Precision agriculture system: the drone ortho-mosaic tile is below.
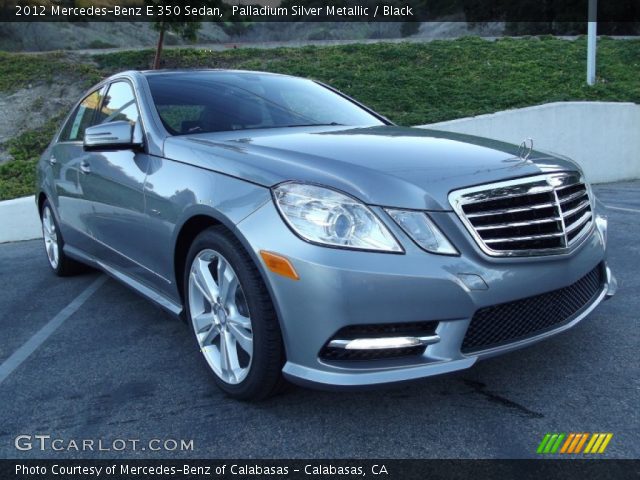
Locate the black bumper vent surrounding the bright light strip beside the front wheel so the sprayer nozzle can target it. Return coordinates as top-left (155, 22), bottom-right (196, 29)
top-left (320, 321), bottom-right (438, 360)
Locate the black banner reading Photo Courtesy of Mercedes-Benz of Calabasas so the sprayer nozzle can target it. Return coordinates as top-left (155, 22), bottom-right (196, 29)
top-left (0, 459), bottom-right (640, 480)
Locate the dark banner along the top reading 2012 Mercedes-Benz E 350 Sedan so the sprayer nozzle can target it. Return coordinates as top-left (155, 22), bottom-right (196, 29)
top-left (0, 0), bottom-right (640, 23)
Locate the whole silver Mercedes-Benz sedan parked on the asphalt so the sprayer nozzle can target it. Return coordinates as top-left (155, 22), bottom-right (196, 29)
top-left (36, 70), bottom-right (615, 399)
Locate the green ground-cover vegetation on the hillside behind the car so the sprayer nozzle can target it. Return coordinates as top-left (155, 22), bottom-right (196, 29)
top-left (0, 37), bottom-right (640, 199)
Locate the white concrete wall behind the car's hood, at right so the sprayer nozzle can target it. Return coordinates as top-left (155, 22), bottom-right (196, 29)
top-left (421, 102), bottom-right (640, 183)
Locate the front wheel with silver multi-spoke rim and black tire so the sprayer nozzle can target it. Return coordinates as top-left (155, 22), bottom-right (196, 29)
top-left (183, 227), bottom-right (285, 401)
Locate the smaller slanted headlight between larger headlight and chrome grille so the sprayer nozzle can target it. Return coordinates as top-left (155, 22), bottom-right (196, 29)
top-left (387, 209), bottom-right (458, 255)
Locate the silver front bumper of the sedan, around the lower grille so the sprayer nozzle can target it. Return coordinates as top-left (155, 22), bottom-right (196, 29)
top-left (237, 202), bottom-right (615, 387)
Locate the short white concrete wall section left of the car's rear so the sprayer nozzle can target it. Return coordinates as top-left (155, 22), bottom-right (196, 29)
top-left (0, 195), bottom-right (42, 243)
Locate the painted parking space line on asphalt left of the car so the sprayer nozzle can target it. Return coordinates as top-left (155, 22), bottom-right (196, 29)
top-left (0, 275), bottom-right (108, 384)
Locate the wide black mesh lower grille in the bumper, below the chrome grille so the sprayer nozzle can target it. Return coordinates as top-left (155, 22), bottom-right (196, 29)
top-left (462, 265), bottom-right (604, 353)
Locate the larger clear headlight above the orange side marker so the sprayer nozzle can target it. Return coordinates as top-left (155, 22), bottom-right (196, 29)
top-left (273, 183), bottom-right (403, 253)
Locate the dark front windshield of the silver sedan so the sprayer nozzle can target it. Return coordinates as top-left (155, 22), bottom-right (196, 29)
top-left (147, 72), bottom-right (383, 135)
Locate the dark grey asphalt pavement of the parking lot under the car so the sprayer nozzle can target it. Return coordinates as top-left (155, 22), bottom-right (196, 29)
top-left (0, 182), bottom-right (640, 459)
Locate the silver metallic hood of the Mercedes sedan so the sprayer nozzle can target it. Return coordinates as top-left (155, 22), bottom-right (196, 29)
top-left (164, 125), bottom-right (578, 210)
